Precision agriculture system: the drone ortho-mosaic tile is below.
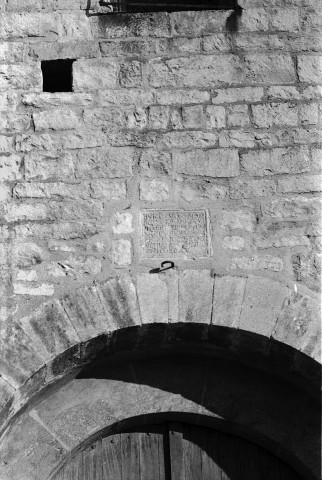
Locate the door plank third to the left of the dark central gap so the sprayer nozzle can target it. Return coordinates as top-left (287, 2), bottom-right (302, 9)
top-left (102, 434), bottom-right (122, 480)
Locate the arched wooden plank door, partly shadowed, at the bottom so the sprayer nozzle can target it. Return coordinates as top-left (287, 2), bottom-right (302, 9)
top-left (54, 423), bottom-right (300, 480)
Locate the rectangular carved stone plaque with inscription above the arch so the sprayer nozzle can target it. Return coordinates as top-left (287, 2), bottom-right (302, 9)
top-left (141, 210), bottom-right (209, 259)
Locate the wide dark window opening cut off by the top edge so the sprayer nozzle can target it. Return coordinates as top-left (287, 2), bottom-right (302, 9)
top-left (100, 0), bottom-right (238, 13)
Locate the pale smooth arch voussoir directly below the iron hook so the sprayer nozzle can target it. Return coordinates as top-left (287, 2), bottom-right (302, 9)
top-left (136, 273), bottom-right (170, 324)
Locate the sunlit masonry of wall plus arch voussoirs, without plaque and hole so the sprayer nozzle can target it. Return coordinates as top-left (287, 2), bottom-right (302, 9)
top-left (0, 0), bottom-right (322, 480)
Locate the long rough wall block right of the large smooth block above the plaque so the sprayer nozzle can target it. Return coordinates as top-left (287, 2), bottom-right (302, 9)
top-left (241, 146), bottom-right (312, 177)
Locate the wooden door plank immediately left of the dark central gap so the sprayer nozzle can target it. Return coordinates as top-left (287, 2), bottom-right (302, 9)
top-left (140, 427), bottom-right (165, 480)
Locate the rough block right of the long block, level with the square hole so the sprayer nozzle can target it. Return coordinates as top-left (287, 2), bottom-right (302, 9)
top-left (244, 54), bottom-right (296, 84)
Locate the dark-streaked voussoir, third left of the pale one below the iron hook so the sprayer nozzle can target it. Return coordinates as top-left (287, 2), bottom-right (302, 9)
top-left (20, 300), bottom-right (79, 360)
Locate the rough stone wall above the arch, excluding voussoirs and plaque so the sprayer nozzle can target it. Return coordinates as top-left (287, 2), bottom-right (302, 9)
top-left (0, 0), bottom-right (322, 317)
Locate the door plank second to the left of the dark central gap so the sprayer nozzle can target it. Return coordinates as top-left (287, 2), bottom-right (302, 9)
top-left (120, 432), bottom-right (140, 480)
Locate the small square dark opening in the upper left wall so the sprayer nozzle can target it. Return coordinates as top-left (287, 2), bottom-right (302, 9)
top-left (41, 59), bottom-right (75, 93)
